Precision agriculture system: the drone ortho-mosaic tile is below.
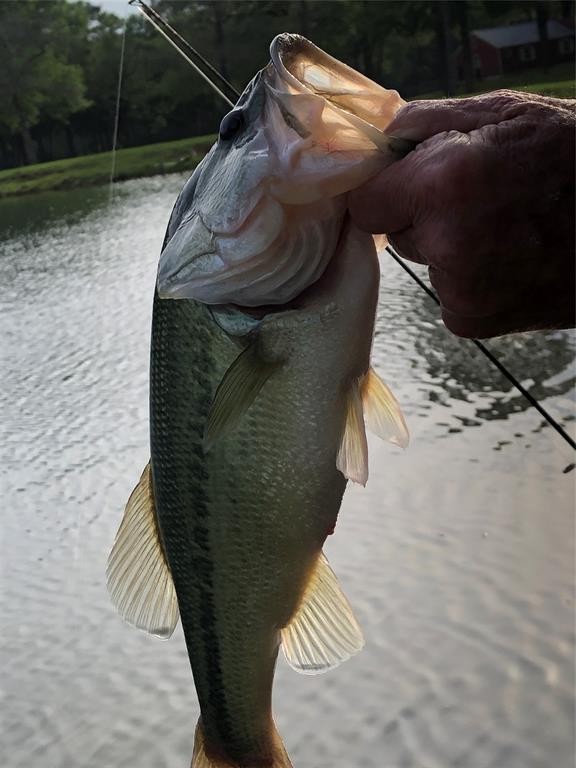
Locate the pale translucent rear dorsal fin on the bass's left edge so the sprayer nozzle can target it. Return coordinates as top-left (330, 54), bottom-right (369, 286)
top-left (106, 462), bottom-right (179, 639)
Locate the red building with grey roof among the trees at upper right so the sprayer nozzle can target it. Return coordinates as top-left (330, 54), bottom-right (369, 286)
top-left (466, 21), bottom-right (574, 78)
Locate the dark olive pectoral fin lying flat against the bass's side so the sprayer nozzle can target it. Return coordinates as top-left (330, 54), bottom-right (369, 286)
top-left (204, 344), bottom-right (280, 451)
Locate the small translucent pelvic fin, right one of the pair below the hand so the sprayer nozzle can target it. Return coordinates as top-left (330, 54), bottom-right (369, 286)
top-left (360, 368), bottom-right (409, 448)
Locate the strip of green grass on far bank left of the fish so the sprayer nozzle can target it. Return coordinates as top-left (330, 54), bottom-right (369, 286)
top-left (0, 136), bottom-right (216, 197)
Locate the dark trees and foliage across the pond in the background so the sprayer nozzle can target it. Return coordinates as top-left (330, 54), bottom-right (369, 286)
top-left (0, 0), bottom-right (574, 167)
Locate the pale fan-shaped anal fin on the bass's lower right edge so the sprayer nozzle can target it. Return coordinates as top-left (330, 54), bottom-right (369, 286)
top-left (281, 553), bottom-right (364, 675)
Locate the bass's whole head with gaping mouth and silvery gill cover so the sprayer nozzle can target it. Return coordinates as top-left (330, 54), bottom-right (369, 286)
top-left (158, 34), bottom-right (404, 307)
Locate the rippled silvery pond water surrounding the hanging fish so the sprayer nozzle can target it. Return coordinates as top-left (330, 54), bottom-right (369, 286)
top-left (0, 176), bottom-right (575, 768)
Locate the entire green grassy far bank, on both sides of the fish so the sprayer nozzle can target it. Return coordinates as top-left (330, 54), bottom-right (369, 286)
top-left (0, 64), bottom-right (576, 198)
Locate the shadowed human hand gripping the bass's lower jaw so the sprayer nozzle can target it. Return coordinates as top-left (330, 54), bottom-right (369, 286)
top-left (349, 91), bottom-right (576, 338)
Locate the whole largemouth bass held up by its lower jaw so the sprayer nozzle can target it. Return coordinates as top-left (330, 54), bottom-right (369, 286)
top-left (108, 35), bottom-right (407, 768)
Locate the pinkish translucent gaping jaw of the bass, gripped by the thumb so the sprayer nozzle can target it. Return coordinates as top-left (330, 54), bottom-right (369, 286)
top-left (264, 33), bottom-right (406, 202)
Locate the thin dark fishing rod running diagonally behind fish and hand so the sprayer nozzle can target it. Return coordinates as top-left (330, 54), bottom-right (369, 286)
top-left (129, 0), bottom-right (576, 456)
